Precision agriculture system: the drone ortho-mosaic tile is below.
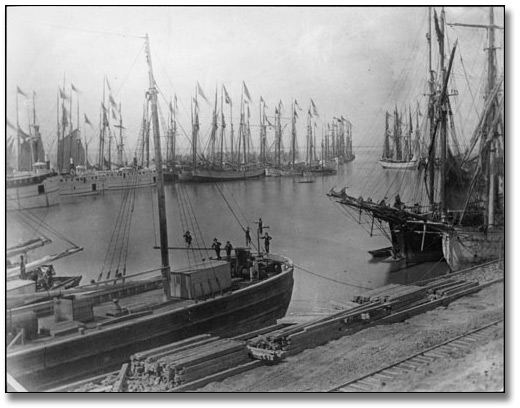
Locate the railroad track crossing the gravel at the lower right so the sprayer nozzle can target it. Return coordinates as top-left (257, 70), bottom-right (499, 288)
top-left (327, 319), bottom-right (504, 392)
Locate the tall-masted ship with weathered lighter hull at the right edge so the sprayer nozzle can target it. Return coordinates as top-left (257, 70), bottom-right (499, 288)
top-left (436, 7), bottom-right (505, 270)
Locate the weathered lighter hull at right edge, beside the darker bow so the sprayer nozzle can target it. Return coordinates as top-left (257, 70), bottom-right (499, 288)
top-left (442, 228), bottom-right (505, 271)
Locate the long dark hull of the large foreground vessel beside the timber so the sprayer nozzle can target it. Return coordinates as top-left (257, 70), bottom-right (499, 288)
top-left (7, 266), bottom-right (294, 390)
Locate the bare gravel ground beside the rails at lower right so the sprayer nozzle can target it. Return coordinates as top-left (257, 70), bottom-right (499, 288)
top-left (198, 266), bottom-right (505, 392)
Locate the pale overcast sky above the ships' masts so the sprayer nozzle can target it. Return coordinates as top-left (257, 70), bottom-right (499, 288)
top-left (6, 7), bottom-right (503, 163)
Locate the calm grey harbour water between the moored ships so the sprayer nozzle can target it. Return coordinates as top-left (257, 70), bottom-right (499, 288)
top-left (7, 148), bottom-right (447, 314)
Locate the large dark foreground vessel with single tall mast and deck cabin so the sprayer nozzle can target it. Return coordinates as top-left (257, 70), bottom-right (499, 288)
top-left (7, 36), bottom-right (294, 390)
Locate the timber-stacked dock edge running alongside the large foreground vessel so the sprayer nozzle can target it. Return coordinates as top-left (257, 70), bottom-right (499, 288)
top-left (45, 277), bottom-right (503, 392)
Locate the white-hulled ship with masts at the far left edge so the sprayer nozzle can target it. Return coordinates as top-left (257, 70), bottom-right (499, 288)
top-left (5, 88), bottom-right (59, 211)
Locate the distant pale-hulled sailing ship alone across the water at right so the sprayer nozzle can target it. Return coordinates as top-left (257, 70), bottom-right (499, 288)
top-left (379, 107), bottom-right (420, 170)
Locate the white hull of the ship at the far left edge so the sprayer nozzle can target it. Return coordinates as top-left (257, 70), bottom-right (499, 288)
top-left (6, 175), bottom-right (60, 211)
